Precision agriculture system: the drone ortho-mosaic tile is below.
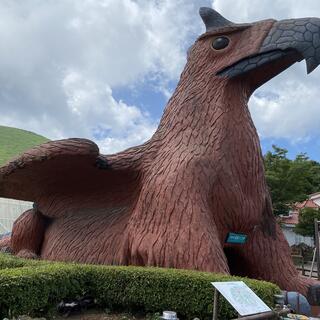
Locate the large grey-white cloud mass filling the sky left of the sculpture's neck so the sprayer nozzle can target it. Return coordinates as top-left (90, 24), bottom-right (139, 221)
top-left (0, 0), bottom-right (205, 152)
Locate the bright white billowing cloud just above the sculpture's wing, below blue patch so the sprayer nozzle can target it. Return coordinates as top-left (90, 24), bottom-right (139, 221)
top-left (62, 71), bottom-right (156, 148)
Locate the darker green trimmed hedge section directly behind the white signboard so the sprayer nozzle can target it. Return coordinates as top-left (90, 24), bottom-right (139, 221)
top-left (93, 267), bottom-right (280, 319)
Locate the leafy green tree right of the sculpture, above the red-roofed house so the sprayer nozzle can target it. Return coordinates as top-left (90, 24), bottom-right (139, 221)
top-left (264, 145), bottom-right (320, 215)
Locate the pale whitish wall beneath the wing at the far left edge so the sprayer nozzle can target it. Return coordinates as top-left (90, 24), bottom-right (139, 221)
top-left (0, 198), bottom-right (33, 234)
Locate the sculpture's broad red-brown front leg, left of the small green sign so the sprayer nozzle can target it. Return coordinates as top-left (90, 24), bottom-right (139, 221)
top-left (127, 173), bottom-right (229, 273)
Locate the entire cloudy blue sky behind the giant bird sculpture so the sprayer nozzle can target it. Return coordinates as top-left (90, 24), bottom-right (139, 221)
top-left (0, 0), bottom-right (320, 161)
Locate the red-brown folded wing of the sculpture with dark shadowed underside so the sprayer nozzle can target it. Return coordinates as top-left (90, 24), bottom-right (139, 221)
top-left (0, 139), bottom-right (134, 201)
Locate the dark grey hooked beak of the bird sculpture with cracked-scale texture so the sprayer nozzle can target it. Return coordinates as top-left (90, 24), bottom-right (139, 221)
top-left (217, 18), bottom-right (320, 78)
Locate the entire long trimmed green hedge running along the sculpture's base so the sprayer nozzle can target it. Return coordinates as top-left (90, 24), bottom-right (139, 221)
top-left (0, 255), bottom-right (279, 319)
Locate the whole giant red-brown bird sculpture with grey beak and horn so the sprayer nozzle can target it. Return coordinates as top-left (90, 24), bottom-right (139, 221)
top-left (0, 8), bottom-right (320, 300)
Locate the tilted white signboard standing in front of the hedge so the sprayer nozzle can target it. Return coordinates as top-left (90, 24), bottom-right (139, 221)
top-left (211, 281), bottom-right (271, 316)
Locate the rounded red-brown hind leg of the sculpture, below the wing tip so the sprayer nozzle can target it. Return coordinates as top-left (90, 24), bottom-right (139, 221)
top-left (11, 209), bottom-right (46, 258)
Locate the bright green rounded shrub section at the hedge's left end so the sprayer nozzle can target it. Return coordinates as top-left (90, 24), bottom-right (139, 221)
top-left (0, 263), bottom-right (92, 317)
